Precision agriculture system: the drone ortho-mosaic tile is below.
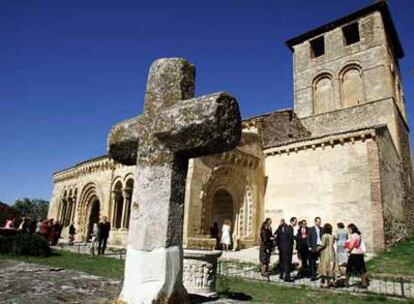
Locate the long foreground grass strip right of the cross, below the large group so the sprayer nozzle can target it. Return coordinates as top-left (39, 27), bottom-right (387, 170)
top-left (217, 277), bottom-right (414, 304)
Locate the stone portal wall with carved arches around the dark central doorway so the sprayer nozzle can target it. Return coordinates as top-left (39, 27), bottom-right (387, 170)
top-left (184, 132), bottom-right (264, 248)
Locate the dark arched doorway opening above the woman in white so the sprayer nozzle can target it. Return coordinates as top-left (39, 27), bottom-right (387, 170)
top-left (210, 189), bottom-right (235, 239)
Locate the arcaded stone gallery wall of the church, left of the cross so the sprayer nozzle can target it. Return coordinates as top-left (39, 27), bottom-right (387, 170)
top-left (48, 156), bottom-right (134, 245)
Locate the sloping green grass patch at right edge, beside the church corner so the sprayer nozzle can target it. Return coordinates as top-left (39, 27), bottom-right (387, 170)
top-left (367, 238), bottom-right (414, 278)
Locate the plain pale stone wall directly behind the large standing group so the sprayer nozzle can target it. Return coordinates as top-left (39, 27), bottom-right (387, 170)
top-left (265, 138), bottom-right (376, 250)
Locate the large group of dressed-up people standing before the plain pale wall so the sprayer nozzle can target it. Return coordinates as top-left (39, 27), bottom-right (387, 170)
top-left (260, 217), bottom-right (369, 288)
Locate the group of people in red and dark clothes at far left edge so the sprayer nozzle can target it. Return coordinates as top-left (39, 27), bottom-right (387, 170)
top-left (4, 216), bottom-right (62, 246)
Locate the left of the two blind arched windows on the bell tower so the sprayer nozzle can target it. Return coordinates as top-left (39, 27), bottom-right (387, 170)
top-left (313, 74), bottom-right (335, 114)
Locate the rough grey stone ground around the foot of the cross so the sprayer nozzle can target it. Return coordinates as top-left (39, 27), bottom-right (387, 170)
top-left (0, 259), bottom-right (242, 304)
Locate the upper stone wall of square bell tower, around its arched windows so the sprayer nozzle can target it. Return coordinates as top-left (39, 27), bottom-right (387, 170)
top-left (293, 12), bottom-right (405, 118)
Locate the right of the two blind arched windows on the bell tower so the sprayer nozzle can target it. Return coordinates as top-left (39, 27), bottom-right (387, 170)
top-left (341, 66), bottom-right (364, 108)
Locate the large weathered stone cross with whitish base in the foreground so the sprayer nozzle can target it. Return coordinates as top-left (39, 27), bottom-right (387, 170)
top-left (108, 58), bottom-right (241, 303)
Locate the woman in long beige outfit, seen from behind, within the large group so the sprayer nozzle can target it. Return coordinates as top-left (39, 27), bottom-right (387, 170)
top-left (317, 223), bottom-right (340, 288)
